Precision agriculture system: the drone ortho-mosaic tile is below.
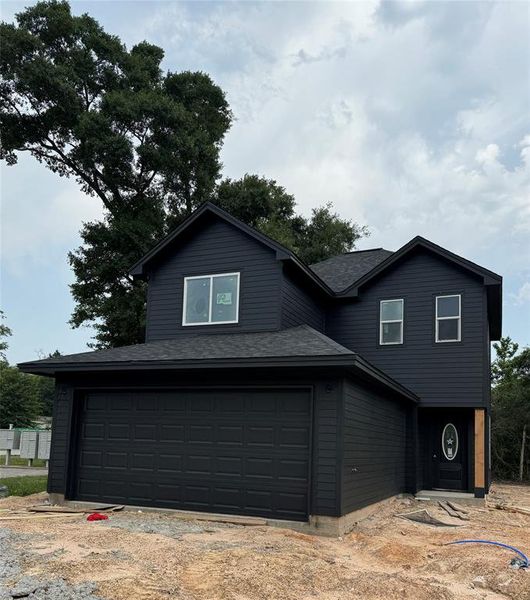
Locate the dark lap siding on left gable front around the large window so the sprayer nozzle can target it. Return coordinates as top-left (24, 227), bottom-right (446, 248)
top-left (146, 220), bottom-right (281, 342)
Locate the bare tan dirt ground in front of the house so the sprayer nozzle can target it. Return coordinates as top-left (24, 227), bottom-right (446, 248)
top-left (0, 484), bottom-right (530, 600)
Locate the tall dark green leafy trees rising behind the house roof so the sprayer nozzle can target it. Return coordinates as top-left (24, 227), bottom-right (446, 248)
top-left (0, 1), bottom-right (366, 347)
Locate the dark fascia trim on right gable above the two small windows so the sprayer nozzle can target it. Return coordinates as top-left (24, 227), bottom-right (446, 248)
top-left (337, 235), bottom-right (502, 297)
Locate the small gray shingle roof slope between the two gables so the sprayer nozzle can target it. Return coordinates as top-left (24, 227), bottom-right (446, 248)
top-left (310, 248), bottom-right (393, 292)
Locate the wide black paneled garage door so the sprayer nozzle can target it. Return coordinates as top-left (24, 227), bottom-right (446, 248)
top-left (74, 389), bottom-right (310, 520)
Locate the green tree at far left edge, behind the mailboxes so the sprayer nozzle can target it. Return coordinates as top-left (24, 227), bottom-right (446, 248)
top-left (0, 361), bottom-right (41, 427)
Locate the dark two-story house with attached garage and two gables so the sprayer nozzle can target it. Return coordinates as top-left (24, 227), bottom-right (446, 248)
top-left (20, 203), bottom-right (502, 533)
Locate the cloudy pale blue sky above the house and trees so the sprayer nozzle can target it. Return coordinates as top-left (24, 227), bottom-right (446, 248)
top-left (1, 1), bottom-right (530, 362)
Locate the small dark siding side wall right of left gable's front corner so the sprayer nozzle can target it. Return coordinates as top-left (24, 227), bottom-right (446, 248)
top-left (281, 271), bottom-right (324, 331)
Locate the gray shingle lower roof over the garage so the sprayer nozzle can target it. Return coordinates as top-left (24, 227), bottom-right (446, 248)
top-left (18, 325), bottom-right (418, 402)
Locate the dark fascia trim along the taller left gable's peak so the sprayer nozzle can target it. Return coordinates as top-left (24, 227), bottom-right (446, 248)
top-left (129, 202), bottom-right (335, 296)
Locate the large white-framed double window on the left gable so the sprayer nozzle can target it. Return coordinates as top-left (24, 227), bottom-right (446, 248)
top-left (182, 273), bottom-right (239, 325)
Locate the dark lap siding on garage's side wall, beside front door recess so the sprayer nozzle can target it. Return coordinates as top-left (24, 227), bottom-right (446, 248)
top-left (341, 380), bottom-right (411, 514)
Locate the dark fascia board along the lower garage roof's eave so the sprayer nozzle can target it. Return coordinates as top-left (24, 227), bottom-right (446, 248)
top-left (18, 352), bottom-right (419, 402)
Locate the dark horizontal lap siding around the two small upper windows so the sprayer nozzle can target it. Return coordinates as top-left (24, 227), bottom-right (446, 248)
top-left (326, 251), bottom-right (488, 406)
